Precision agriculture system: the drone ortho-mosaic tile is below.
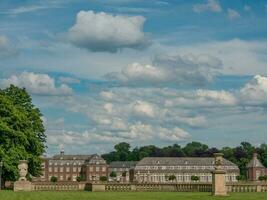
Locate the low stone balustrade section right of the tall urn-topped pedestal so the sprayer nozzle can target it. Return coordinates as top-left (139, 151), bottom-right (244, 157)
top-left (226, 182), bottom-right (267, 192)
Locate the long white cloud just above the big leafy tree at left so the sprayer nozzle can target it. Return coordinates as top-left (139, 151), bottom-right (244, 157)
top-left (0, 72), bottom-right (72, 95)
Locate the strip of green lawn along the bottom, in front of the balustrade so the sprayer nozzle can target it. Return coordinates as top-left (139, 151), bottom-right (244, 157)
top-left (0, 191), bottom-right (267, 200)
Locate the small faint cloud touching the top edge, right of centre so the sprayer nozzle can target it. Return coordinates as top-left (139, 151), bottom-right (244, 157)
top-left (193, 0), bottom-right (222, 13)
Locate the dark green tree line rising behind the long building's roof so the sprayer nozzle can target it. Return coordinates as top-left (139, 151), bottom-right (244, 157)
top-left (102, 142), bottom-right (267, 176)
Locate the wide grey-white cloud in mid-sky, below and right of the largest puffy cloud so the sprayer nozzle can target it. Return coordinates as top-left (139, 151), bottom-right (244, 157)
top-left (106, 54), bottom-right (222, 86)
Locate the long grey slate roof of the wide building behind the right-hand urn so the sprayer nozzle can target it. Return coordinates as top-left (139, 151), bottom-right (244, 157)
top-left (136, 157), bottom-right (236, 166)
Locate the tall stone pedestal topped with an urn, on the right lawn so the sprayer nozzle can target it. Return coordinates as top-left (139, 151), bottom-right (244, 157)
top-left (212, 153), bottom-right (227, 196)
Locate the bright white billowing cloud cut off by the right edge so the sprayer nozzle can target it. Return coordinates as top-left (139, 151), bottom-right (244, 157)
top-left (240, 75), bottom-right (267, 105)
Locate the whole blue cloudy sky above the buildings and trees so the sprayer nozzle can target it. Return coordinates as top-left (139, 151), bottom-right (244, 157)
top-left (0, 0), bottom-right (267, 155)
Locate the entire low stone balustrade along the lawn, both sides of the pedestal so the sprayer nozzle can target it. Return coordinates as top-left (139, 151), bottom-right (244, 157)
top-left (32, 182), bottom-right (267, 192)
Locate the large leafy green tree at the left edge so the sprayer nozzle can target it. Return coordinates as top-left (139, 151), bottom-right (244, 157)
top-left (0, 85), bottom-right (46, 180)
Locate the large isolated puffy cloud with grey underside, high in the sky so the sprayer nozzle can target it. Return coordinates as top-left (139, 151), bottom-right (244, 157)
top-left (68, 11), bottom-right (148, 52)
